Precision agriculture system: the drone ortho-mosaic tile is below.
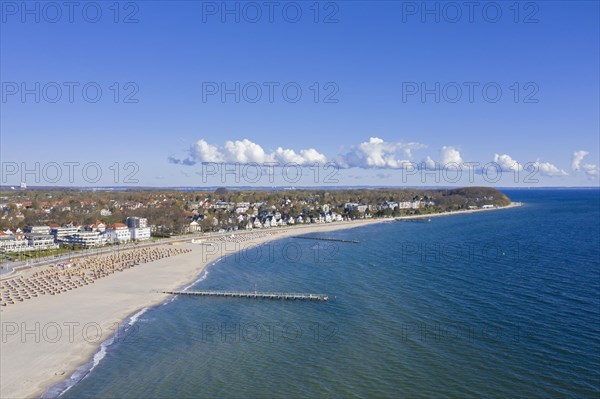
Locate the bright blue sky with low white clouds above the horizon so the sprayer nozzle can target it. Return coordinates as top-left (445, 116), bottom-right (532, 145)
top-left (0, 1), bottom-right (600, 186)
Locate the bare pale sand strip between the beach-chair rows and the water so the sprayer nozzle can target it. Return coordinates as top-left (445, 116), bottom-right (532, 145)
top-left (0, 204), bottom-right (520, 398)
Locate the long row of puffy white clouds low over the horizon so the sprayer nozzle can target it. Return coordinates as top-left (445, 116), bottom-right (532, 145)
top-left (168, 137), bottom-right (600, 179)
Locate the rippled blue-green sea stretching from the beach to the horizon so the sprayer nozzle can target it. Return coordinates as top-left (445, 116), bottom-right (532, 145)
top-left (57, 190), bottom-right (600, 398)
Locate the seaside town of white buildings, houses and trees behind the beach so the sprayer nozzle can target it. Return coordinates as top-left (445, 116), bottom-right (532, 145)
top-left (0, 188), bottom-right (509, 254)
